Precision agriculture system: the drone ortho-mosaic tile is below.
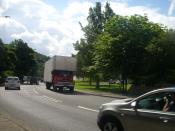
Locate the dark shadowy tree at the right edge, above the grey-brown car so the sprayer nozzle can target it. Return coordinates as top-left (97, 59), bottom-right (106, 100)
top-left (146, 30), bottom-right (175, 85)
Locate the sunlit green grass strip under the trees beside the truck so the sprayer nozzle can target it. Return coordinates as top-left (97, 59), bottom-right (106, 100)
top-left (75, 81), bottom-right (121, 93)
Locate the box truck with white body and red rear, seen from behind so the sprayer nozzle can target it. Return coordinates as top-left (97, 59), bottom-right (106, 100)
top-left (44, 56), bottom-right (77, 92)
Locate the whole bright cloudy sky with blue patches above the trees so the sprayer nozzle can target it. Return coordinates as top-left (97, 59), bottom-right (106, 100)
top-left (0, 0), bottom-right (175, 56)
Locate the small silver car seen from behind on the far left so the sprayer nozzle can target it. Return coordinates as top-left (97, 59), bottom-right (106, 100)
top-left (5, 76), bottom-right (20, 90)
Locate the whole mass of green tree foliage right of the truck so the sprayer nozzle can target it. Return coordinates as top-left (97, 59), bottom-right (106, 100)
top-left (74, 2), bottom-right (175, 89)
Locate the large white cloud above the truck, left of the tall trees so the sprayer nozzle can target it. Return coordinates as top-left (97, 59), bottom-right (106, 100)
top-left (0, 0), bottom-right (92, 56)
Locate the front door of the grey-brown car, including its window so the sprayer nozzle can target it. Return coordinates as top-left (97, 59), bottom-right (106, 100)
top-left (123, 93), bottom-right (175, 131)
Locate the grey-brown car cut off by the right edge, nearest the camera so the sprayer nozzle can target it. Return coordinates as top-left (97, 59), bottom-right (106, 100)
top-left (97, 87), bottom-right (175, 131)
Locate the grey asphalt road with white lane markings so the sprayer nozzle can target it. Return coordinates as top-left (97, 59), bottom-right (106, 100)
top-left (0, 85), bottom-right (114, 131)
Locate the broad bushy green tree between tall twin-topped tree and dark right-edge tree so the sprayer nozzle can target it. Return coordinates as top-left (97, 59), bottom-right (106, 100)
top-left (95, 15), bottom-right (164, 88)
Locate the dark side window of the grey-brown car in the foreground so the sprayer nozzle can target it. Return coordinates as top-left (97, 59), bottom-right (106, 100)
top-left (137, 93), bottom-right (174, 111)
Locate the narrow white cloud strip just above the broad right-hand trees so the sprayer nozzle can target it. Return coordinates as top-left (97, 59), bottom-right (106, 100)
top-left (111, 2), bottom-right (175, 28)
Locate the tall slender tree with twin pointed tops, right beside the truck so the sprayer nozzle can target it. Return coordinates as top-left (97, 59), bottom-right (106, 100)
top-left (74, 2), bottom-right (114, 87)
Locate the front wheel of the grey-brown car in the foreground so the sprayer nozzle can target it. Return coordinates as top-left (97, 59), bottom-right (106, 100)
top-left (102, 120), bottom-right (120, 131)
